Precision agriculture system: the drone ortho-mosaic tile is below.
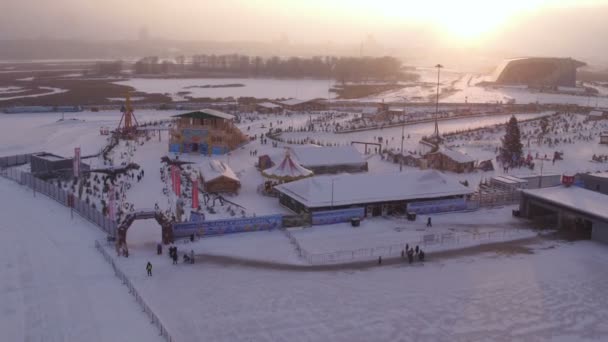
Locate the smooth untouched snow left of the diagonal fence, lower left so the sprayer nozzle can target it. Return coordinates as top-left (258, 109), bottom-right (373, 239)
top-left (0, 178), bottom-right (161, 342)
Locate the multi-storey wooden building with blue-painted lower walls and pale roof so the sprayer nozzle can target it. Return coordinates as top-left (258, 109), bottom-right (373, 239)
top-left (169, 109), bottom-right (249, 155)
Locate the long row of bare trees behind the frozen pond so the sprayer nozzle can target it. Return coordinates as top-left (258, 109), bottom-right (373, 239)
top-left (134, 54), bottom-right (418, 83)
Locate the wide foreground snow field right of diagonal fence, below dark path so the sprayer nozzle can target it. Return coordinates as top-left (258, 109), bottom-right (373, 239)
top-left (105, 228), bottom-right (608, 341)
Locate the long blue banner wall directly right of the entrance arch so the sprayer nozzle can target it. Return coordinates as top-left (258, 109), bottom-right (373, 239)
top-left (173, 215), bottom-right (283, 237)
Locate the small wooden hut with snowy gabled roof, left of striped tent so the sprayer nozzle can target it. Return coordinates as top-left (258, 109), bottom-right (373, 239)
top-left (199, 160), bottom-right (241, 193)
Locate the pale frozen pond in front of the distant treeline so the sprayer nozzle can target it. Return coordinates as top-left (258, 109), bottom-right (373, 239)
top-left (116, 78), bottom-right (334, 100)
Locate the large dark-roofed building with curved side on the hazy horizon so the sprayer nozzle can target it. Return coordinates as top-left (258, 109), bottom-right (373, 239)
top-left (494, 57), bottom-right (586, 87)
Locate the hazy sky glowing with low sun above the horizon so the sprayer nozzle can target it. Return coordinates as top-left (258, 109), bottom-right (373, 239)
top-left (0, 0), bottom-right (608, 63)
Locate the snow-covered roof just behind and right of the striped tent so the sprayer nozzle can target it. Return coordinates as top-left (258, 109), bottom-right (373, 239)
top-left (291, 145), bottom-right (365, 168)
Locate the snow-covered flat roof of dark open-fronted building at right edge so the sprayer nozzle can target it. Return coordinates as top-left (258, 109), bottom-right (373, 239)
top-left (522, 186), bottom-right (608, 220)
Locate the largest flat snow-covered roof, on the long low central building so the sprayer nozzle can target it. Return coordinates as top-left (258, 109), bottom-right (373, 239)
top-left (275, 170), bottom-right (473, 208)
